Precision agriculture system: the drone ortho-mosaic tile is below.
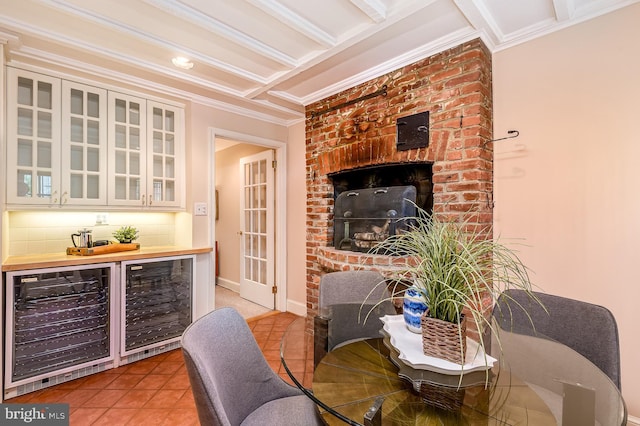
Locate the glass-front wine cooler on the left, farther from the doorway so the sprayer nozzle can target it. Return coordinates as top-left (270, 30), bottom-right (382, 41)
top-left (5, 263), bottom-right (115, 397)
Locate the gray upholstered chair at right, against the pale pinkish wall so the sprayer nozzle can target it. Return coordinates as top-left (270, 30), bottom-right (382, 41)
top-left (493, 289), bottom-right (621, 389)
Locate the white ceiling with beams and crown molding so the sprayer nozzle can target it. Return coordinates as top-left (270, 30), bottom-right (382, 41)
top-left (0, 0), bottom-right (640, 124)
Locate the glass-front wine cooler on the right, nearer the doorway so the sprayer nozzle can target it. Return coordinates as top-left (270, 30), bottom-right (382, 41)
top-left (120, 256), bottom-right (195, 364)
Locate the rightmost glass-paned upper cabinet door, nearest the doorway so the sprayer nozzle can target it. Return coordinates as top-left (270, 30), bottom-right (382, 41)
top-left (147, 101), bottom-right (182, 206)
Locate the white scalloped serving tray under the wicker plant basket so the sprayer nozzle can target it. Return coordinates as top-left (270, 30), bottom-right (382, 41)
top-left (380, 315), bottom-right (497, 374)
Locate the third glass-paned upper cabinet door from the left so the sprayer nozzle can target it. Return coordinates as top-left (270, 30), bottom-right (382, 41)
top-left (108, 92), bottom-right (147, 206)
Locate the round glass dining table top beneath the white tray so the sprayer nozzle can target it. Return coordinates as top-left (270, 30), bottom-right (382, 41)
top-left (280, 306), bottom-right (627, 426)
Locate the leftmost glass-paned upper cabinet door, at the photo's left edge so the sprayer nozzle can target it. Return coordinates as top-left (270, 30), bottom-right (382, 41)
top-left (7, 68), bottom-right (61, 204)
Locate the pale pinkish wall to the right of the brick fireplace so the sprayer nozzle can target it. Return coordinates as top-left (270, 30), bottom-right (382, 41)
top-left (493, 4), bottom-right (640, 417)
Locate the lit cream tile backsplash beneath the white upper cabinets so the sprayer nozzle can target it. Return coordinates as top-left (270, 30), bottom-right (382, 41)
top-left (8, 211), bottom-right (175, 256)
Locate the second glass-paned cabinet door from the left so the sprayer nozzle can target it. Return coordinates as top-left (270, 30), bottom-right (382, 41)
top-left (61, 81), bottom-right (107, 205)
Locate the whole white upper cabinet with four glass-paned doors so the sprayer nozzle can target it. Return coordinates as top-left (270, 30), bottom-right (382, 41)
top-left (6, 67), bottom-right (184, 210)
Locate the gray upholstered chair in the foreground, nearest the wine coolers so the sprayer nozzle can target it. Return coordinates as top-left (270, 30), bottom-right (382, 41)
top-left (182, 308), bottom-right (323, 426)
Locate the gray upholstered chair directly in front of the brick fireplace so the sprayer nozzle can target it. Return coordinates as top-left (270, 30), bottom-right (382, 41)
top-left (314, 271), bottom-right (396, 365)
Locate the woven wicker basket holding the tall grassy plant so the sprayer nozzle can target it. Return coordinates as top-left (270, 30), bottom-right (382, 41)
top-left (420, 313), bottom-right (467, 364)
